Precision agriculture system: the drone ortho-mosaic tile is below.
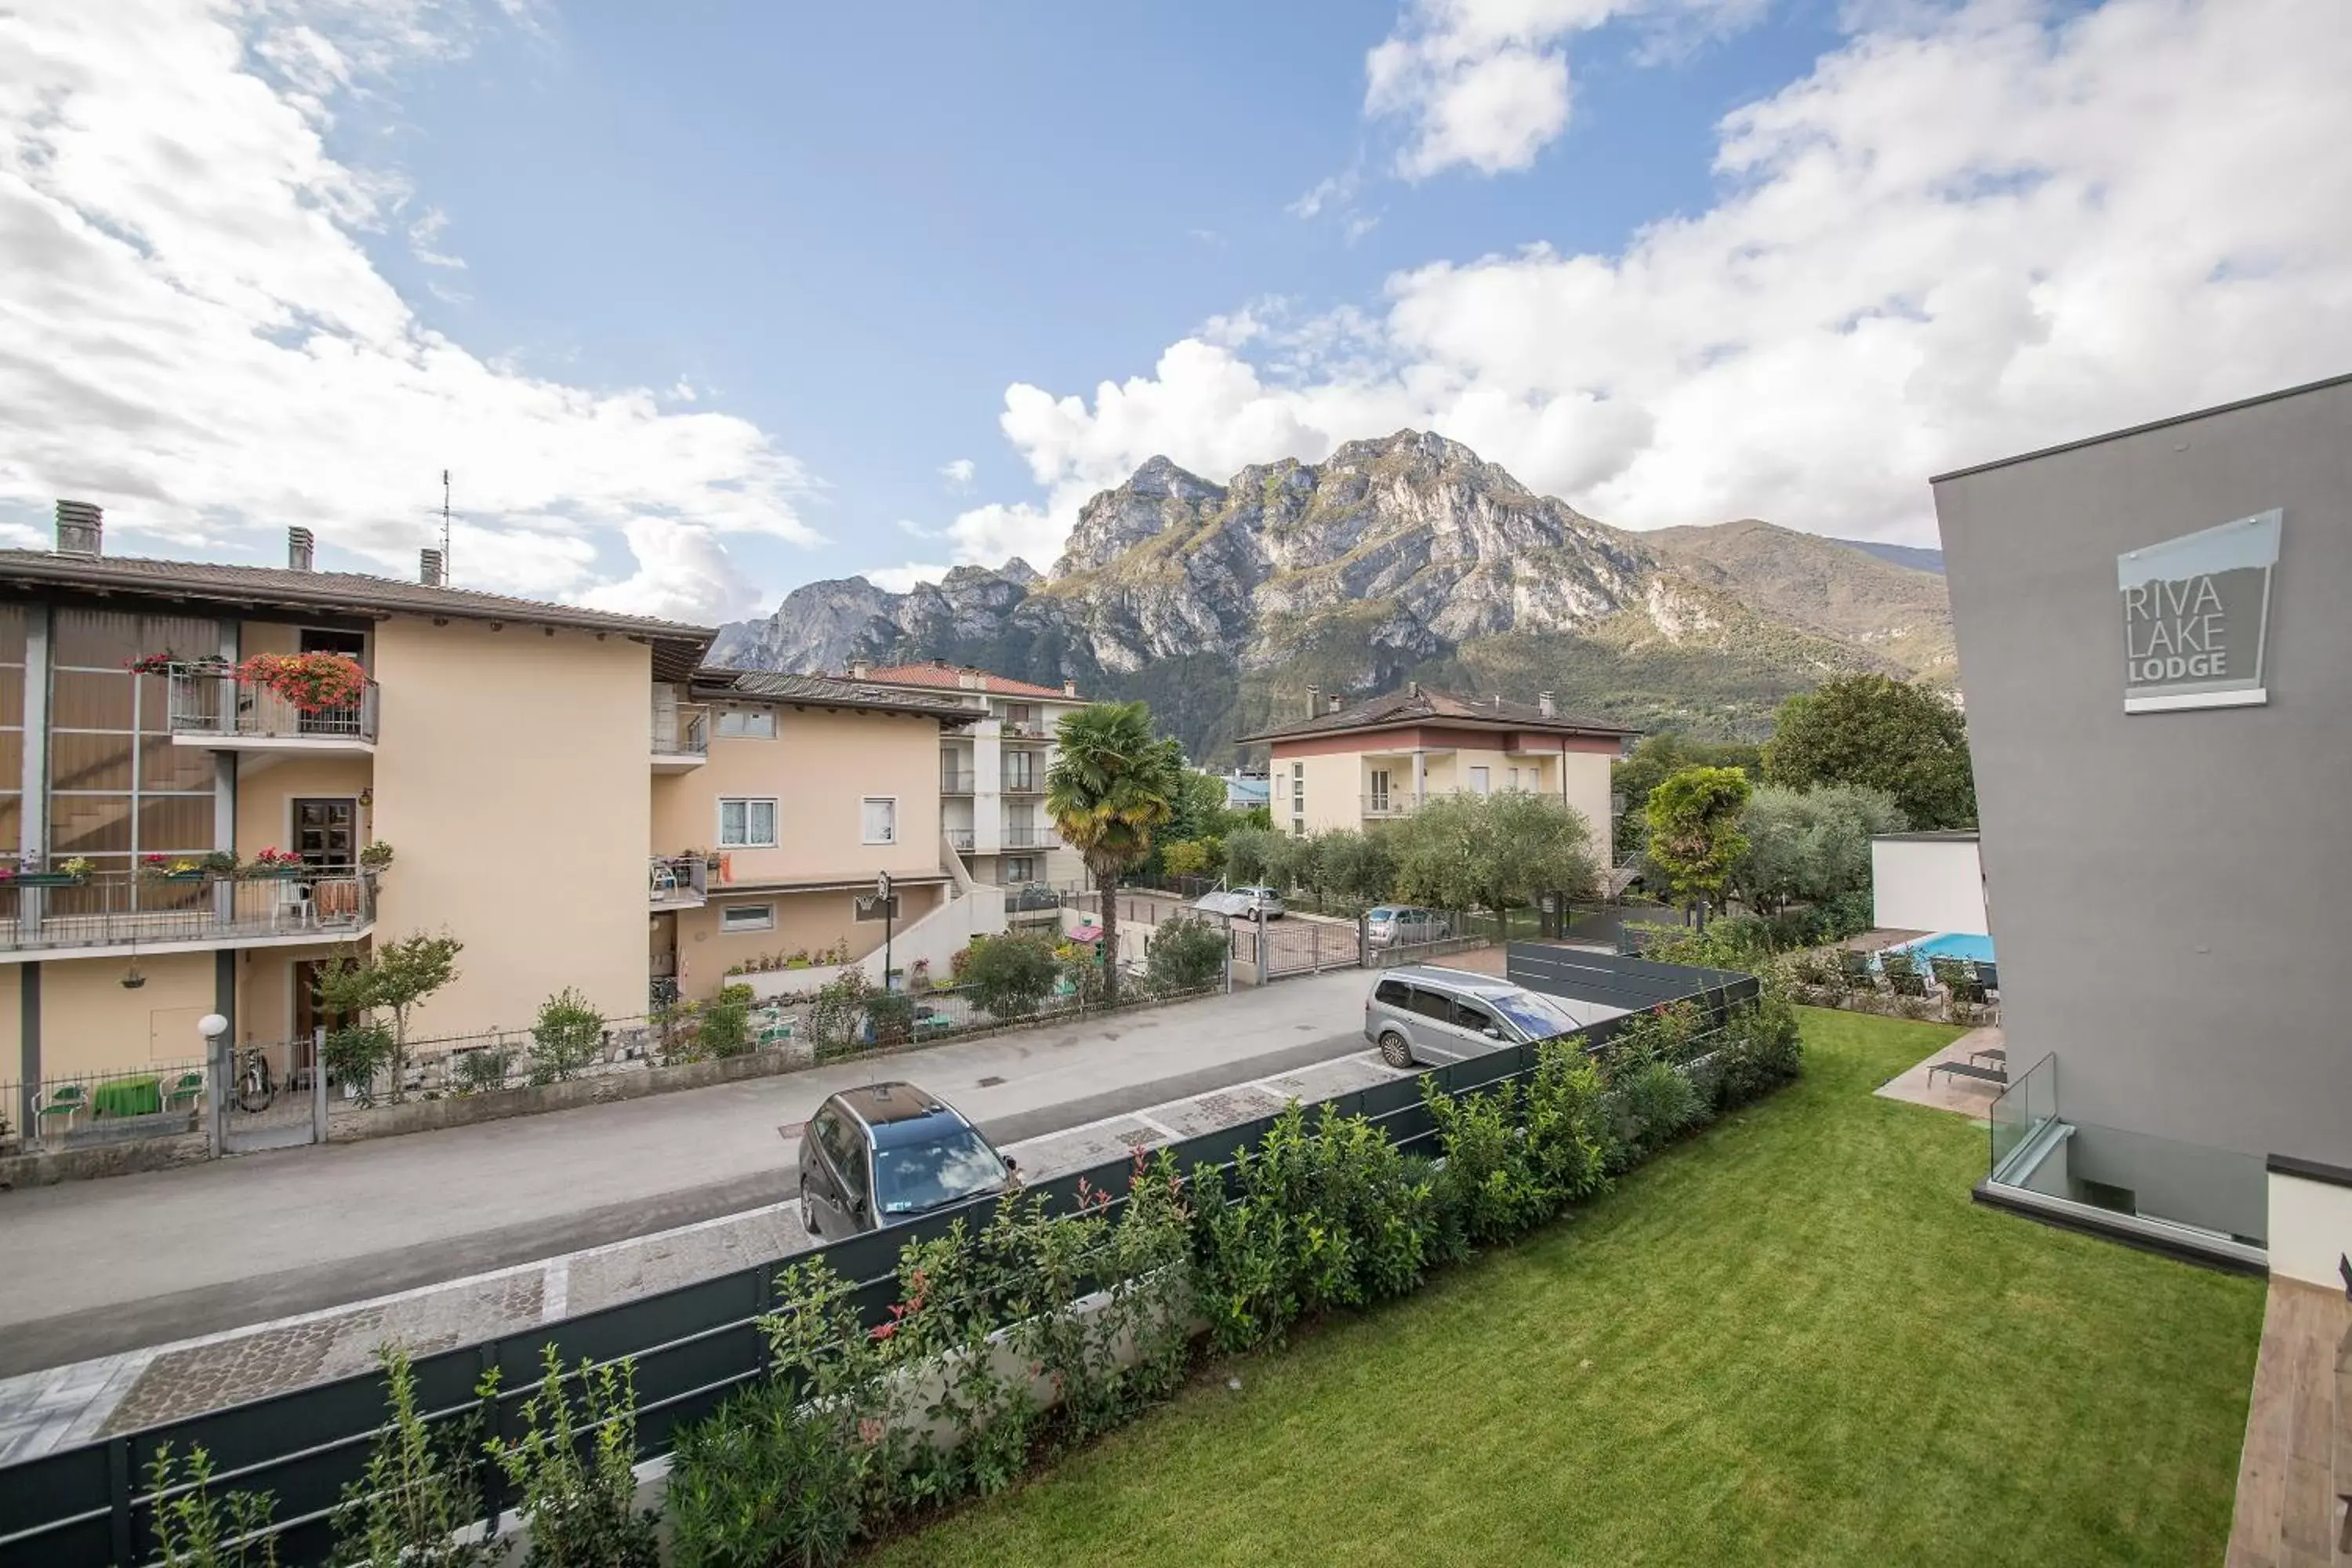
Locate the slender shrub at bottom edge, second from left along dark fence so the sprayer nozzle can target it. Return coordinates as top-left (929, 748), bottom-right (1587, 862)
top-left (334, 1342), bottom-right (492, 1568)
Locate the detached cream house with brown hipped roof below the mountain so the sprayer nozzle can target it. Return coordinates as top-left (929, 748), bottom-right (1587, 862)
top-left (1242, 682), bottom-right (1639, 865)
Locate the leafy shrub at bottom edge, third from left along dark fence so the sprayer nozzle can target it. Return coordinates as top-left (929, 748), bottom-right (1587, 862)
top-left (482, 1345), bottom-right (661, 1568)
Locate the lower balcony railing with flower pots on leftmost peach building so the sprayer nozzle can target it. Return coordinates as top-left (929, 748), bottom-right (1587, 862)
top-left (0, 865), bottom-right (376, 952)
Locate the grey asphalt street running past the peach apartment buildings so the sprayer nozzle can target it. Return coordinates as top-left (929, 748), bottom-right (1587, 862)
top-left (0, 971), bottom-right (1371, 1375)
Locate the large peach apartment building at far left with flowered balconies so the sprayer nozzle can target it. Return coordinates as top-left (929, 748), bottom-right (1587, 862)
top-left (0, 503), bottom-right (713, 1116)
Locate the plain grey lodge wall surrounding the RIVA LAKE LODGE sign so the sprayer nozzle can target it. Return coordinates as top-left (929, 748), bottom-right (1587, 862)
top-left (1936, 383), bottom-right (2352, 1163)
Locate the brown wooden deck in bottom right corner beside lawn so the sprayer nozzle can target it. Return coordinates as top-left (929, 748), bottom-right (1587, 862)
top-left (2227, 1279), bottom-right (2352, 1568)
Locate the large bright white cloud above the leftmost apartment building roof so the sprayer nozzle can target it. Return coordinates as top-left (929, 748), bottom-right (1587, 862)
top-left (0, 0), bottom-right (816, 616)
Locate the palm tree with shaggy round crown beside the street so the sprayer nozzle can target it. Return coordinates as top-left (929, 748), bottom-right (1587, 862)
top-left (1044, 703), bottom-right (1183, 1001)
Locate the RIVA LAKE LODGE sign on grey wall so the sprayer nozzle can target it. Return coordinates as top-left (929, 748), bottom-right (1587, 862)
top-left (2114, 510), bottom-right (2281, 713)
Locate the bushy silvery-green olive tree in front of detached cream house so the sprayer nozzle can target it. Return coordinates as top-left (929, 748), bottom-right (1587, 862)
top-left (1388, 789), bottom-right (1599, 928)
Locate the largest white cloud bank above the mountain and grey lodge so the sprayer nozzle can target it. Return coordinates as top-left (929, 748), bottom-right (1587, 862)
top-left (953, 0), bottom-right (2352, 564)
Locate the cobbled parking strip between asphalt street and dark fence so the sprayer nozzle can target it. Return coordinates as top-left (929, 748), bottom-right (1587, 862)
top-left (0, 1041), bottom-right (1404, 1465)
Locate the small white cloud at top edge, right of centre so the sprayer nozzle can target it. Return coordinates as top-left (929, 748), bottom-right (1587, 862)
top-left (1364, 0), bottom-right (1766, 178)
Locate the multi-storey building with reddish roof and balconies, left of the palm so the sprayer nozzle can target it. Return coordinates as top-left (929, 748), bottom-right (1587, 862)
top-left (849, 659), bottom-right (1087, 888)
